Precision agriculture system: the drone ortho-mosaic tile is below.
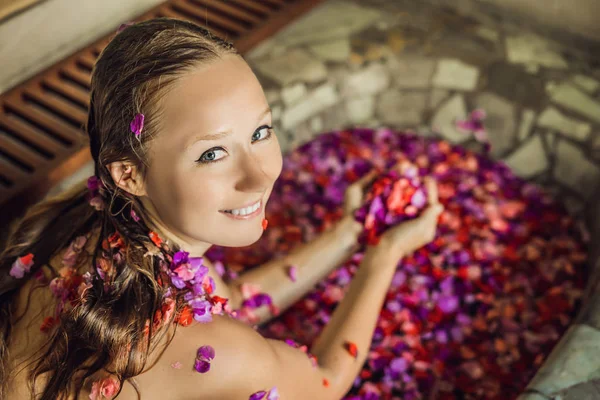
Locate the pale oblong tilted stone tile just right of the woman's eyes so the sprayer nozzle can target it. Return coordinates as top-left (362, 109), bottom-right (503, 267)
top-left (281, 83), bottom-right (339, 130)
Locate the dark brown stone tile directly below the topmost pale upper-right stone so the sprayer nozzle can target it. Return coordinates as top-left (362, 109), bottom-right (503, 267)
top-left (486, 62), bottom-right (546, 111)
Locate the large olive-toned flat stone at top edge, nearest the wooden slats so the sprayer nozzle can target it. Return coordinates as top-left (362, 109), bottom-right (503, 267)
top-left (277, 0), bottom-right (382, 46)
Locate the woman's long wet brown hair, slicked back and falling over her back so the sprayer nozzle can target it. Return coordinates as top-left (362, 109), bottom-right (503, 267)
top-left (0, 18), bottom-right (239, 400)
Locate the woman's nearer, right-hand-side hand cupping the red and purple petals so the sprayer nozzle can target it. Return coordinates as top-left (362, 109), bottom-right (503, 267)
top-left (371, 177), bottom-right (444, 260)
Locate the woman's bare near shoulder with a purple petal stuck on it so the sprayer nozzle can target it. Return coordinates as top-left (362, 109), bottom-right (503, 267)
top-left (136, 315), bottom-right (341, 400)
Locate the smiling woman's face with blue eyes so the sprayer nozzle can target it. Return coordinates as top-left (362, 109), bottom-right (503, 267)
top-left (142, 55), bottom-right (282, 254)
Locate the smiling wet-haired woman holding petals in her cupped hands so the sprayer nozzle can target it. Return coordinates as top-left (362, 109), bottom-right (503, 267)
top-left (0, 18), bottom-right (442, 400)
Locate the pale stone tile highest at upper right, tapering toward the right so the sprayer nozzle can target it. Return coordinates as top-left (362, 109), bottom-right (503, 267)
top-left (506, 33), bottom-right (569, 69)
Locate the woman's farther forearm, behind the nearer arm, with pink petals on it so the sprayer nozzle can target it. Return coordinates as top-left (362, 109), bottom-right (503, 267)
top-left (228, 215), bottom-right (362, 325)
